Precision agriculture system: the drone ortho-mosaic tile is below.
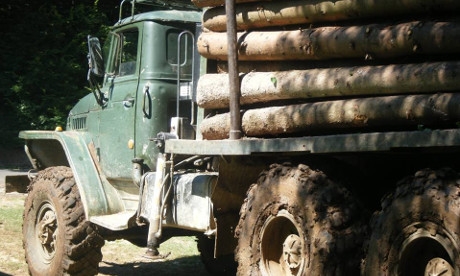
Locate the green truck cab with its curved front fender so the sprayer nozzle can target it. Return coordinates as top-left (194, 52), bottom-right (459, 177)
top-left (20, 2), bottom-right (200, 218)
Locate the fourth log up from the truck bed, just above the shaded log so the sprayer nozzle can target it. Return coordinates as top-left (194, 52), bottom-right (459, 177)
top-left (203, 0), bottom-right (460, 32)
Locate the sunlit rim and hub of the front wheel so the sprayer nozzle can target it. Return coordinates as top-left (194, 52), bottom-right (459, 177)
top-left (35, 202), bottom-right (58, 264)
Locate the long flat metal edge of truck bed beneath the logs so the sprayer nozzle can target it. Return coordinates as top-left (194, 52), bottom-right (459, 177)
top-left (165, 129), bottom-right (460, 155)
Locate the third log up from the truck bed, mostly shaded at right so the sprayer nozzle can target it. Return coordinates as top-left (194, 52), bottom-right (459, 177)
top-left (197, 20), bottom-right (460, 61)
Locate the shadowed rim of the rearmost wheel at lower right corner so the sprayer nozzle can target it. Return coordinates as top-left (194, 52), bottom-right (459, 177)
top-left (397, 225), bottom-right (458, 276)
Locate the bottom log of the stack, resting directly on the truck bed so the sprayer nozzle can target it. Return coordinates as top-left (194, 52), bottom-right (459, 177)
top-left (200, 93), bottom-right (460, 140)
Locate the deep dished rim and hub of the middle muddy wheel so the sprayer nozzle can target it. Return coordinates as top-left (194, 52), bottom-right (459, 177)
top-left (260, 210), bottom-right (307, 275)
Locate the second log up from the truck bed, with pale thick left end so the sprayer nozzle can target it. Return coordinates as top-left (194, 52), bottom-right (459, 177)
top-left (197, 61), bottom-right (460, 109)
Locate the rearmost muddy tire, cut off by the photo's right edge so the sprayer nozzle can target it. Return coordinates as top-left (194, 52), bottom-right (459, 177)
top-left (363, 169), bottom-right (460, 276)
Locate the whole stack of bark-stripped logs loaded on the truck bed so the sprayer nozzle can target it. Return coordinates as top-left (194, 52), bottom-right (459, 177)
top-left (192, 0), bottom-right (460, 139)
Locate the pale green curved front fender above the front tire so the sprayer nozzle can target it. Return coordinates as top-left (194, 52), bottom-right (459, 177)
top-left (19, 131), bottom-right (123, 220)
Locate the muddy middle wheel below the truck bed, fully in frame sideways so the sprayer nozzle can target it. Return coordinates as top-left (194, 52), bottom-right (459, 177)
top-left (236, 164), bottom-right (367, 276)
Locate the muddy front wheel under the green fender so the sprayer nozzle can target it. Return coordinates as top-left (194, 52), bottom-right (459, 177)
top-left (23, 167), bottom-right (104, 275)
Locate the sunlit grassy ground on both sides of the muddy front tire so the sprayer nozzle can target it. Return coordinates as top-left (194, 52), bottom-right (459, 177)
top-left (0, 194), bottom-right (208, 276)
